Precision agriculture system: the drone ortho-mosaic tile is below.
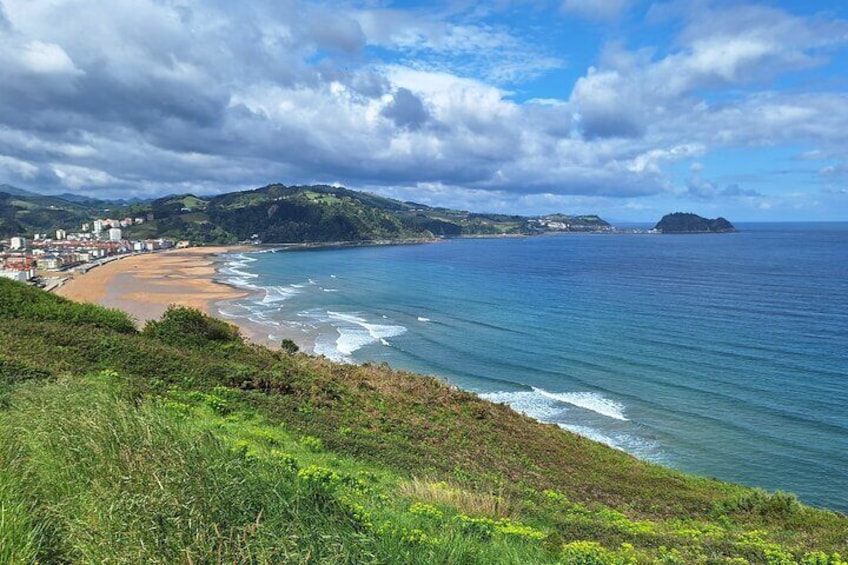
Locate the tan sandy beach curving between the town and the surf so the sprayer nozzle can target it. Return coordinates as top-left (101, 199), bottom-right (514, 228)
top-left (56, 247), bottom-right (296, 346)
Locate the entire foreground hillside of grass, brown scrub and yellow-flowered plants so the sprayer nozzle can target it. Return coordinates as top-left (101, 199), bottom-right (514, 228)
top-left (0, 280), bottom-right (848, 565)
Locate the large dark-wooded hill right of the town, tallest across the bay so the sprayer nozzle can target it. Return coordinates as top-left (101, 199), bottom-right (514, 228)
top-left (128, 184), bottom-right (544, 243)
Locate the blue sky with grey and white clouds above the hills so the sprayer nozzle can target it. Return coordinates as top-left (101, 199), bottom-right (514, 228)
top-left (0, 0), bottom-right (848, 222)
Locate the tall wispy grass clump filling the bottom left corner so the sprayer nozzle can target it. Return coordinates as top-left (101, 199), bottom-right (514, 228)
top-left (0, 377), bottom-right (386, 563)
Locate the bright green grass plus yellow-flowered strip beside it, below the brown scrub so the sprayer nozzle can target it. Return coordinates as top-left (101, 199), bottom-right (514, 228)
top-left (0, 371), bottom-right (568, 565)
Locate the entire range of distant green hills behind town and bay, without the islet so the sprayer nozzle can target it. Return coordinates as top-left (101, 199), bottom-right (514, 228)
top-left (0, 184), bottom-right (611, 244)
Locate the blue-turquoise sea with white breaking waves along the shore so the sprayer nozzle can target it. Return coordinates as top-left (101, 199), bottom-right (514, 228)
top-left (217, 224), bottom-right (848, 511)
